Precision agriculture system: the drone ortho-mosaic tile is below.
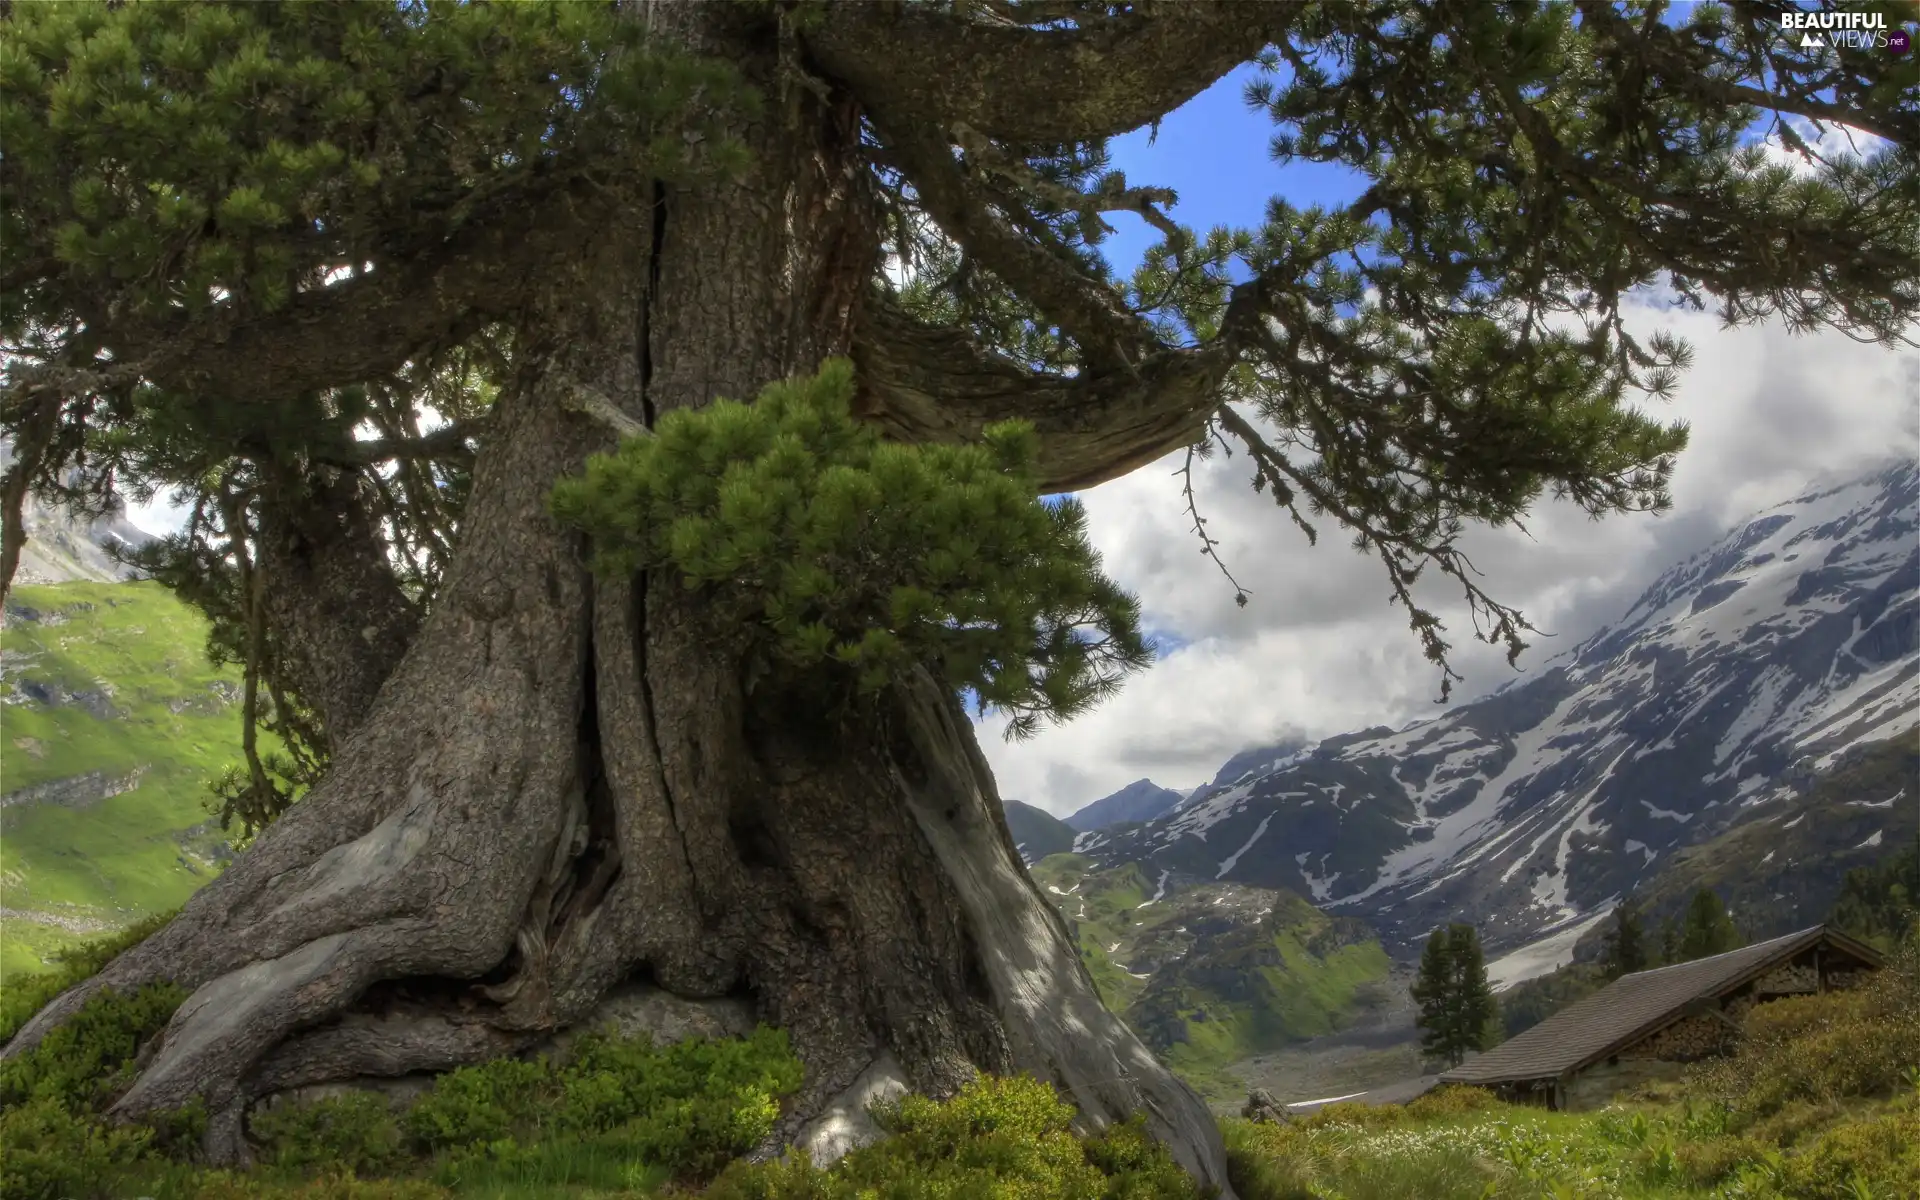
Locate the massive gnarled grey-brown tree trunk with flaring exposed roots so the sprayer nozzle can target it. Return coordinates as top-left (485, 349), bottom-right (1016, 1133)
top-left (6, 6), bottom-right (1227, 1188)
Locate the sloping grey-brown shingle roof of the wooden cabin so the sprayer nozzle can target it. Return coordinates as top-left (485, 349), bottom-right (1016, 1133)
top-left (1440, 925), bottom-right (1882, 1083)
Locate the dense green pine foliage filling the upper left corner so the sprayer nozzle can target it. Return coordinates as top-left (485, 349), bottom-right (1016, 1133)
top-left (0, 0), bottom-right (724, 324)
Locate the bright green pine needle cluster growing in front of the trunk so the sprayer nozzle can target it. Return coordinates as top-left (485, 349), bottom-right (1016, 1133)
top-left (553, 361), bottom-right (1152, 737)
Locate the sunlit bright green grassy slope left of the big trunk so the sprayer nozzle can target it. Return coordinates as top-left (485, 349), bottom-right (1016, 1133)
top-left (0, 584), bottom-right (240, 973)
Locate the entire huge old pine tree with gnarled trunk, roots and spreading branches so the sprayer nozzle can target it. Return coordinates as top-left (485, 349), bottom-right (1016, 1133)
top-left (0, 0), bottom-right (1920, 1198)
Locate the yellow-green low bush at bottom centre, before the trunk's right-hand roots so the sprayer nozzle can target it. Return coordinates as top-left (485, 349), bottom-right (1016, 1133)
top-left (707, 1077), bottom-right (1200, 1200)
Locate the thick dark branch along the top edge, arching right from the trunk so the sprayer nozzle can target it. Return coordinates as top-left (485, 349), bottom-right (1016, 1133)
top-left (803, 0), bottom-right (1294, 144)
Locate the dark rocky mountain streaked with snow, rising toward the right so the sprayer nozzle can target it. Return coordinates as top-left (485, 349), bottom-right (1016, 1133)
top-left (1075, 463), bottom-right (1920, 948)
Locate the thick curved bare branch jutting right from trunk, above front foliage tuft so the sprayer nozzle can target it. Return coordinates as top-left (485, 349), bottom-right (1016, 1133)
top-left (852, 296), bottom-right (1236, 492)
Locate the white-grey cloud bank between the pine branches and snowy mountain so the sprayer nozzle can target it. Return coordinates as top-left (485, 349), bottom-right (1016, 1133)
top-left (981, 300), bottom-right (1920, 814)
